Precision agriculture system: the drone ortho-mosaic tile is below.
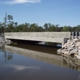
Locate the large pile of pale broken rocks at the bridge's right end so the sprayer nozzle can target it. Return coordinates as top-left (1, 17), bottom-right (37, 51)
top-left (57, 39), bottom-right (80, 59)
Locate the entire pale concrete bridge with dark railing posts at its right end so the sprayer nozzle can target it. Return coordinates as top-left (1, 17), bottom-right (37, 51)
top-left (5, 32), bottom-right (79, 45)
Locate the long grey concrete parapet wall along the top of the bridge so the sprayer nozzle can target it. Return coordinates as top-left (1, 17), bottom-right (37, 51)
top-left (5, 32), bottom-right (70, 38)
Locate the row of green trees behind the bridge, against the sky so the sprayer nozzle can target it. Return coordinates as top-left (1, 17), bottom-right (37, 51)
top-left (0, 15), bottom-right (80, 32)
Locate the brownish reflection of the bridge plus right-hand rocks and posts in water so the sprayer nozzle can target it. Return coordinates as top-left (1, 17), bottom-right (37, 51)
top-left (5, 45), bottom-right (80, 71)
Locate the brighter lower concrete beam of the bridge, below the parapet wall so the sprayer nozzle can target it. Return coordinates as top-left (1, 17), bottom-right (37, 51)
top-left (5, 36), bottom-right (64, 43)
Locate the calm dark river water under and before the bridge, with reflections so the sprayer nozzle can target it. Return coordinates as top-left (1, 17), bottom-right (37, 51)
top-left (0, 44), bottom-right (80, 80)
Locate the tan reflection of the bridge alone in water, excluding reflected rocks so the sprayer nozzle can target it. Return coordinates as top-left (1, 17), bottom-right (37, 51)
top-left (5, 45), bottom-right (63, 66)
